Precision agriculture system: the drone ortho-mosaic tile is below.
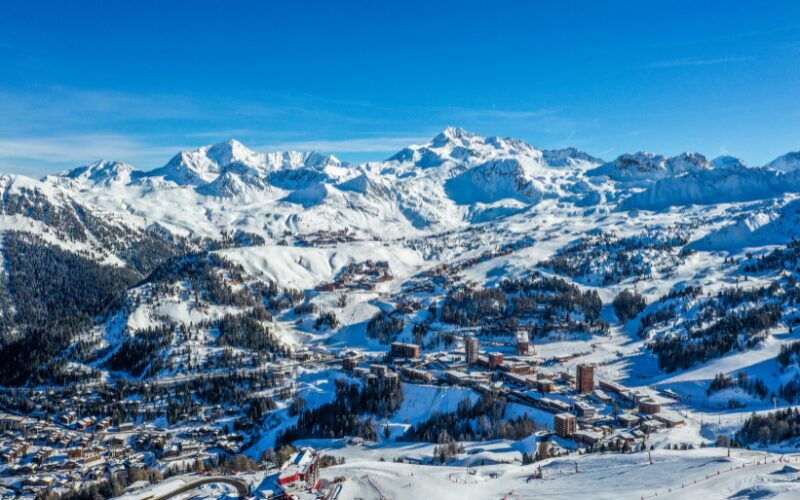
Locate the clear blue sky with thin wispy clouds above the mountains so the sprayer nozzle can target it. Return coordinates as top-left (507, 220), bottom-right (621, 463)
top-left (0, 0), bottom-right (800, 176)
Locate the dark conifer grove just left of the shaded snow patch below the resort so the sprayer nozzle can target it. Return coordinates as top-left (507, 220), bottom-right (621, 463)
top-left (276, 379), bottom-right (403, 446)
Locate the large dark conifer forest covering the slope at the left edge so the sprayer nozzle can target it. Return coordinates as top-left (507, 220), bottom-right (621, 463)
top-left (0, 231), bottom-right (138, 385)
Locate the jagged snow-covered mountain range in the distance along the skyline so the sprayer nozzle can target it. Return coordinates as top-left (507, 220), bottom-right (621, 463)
top-left (28, 127), bottom-right (800, 244)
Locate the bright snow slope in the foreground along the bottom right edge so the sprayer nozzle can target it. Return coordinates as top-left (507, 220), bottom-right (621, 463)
top-left (314, 446), bottom-right (800, 499)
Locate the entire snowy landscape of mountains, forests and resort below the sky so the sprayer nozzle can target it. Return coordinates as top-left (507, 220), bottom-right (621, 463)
top-left (0, 131), bottom-right (800, 500)
